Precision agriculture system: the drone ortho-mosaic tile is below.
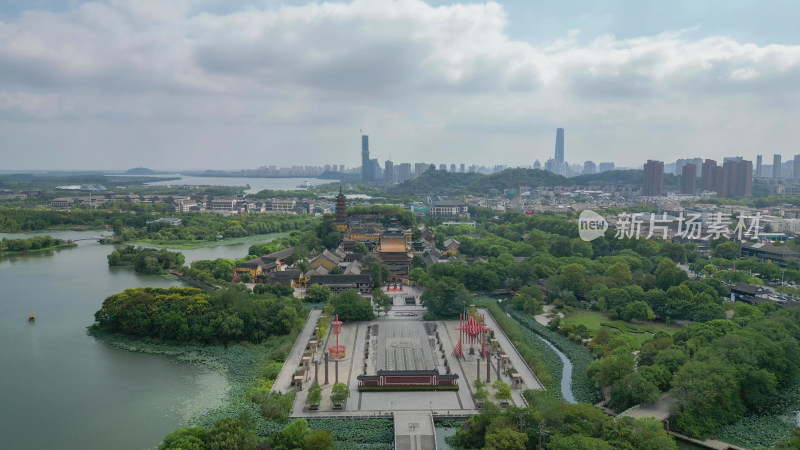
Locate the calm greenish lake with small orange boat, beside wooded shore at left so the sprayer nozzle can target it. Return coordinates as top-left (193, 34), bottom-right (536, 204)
top-left (0, 231), bottom-right (260, 449)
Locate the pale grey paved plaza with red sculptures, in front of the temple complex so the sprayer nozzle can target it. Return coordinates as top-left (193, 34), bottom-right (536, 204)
top-left (282, 306), bottom-right (542, 417)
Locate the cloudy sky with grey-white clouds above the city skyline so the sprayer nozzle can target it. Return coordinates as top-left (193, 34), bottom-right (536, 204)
top-left (0, 0), bottom-right (800, 170)
